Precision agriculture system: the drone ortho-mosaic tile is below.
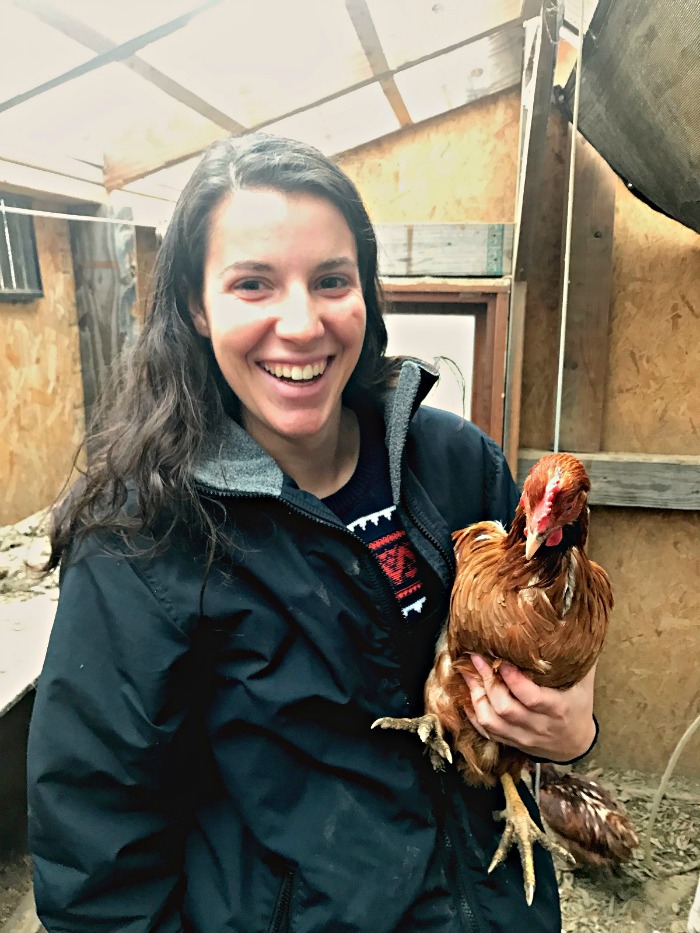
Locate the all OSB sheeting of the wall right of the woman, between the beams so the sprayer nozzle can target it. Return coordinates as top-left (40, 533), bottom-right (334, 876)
top-left (340, 92), bottom-right (700, 776)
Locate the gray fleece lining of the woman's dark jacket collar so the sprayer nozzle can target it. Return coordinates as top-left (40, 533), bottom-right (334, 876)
top-left (193, 360), bottom-right (437, 503)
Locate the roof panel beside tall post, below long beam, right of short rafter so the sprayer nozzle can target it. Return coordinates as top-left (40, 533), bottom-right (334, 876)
top-left (395, 26), bottom-right (523, 121)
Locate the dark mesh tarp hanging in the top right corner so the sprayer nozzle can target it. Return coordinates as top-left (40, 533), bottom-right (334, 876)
top-left (558, 0), bottom-right (700, 232)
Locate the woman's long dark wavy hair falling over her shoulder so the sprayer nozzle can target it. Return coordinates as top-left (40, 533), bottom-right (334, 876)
top-left (46, 134), bottom-right (398, 570)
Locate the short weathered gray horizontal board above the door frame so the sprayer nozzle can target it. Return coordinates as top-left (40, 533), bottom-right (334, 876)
top-left (375, 223), bottom-right (513, 277)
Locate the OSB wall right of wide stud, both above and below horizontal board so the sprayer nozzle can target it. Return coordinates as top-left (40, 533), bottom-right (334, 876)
top-left (591, 182), bottom-right (700, 776)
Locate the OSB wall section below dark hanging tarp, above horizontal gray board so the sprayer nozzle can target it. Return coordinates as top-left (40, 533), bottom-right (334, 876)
top-left (603, 182), bottom-right (700, 454)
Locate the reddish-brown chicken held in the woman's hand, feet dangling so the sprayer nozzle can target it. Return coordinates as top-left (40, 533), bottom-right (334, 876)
top-left (373, 454), bottom-right (613, 905)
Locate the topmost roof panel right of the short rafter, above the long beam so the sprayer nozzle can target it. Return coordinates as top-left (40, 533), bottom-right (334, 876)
top-left (368, 0), bottom-right (521, 68)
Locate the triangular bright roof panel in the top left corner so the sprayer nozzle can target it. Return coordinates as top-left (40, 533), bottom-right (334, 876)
top-left (0, 0), bottom-right (93, 101)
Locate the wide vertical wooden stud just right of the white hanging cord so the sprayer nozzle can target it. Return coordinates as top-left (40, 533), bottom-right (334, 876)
top-left (560, 127), bottom-right (617, 451)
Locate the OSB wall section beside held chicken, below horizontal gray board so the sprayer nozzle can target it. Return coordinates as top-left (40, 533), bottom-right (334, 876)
top-left (590, 508), bottom-right (700, 777)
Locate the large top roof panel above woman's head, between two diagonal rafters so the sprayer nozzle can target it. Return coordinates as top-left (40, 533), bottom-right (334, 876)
top-left (140, 0), bottom-right (372, 127)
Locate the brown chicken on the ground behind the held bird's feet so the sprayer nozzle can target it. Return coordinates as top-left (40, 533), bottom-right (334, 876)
top-left (533, 764), bottom-right (639, 868)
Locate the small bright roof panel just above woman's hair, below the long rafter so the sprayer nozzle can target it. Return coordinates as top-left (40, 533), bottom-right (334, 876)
top-left (266, 84), bottom-right (400, 155)
